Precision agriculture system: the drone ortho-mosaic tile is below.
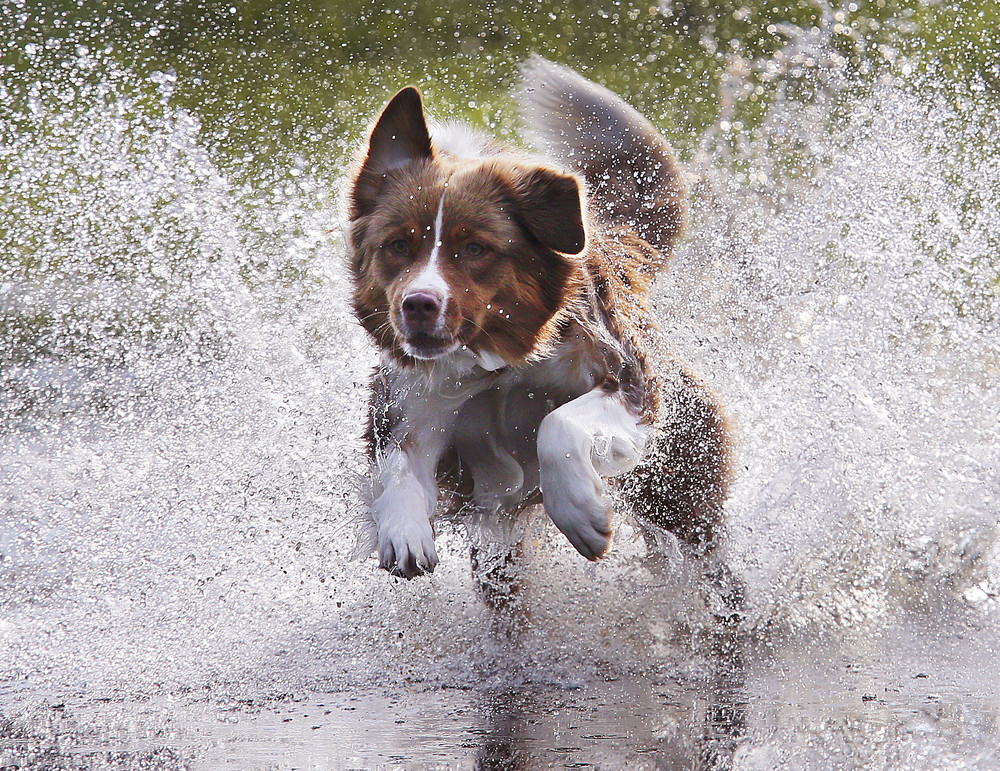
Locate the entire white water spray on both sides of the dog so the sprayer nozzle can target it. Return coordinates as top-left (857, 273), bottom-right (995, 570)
top-left (0, 40), bottom-right (1000, 736)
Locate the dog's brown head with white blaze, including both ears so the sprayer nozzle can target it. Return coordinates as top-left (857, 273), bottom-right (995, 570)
top-left (349, 88), bottom-right (586, 364)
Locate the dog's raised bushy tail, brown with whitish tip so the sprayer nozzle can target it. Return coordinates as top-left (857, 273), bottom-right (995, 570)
top-left (520, 56), bottom-right (687, 257)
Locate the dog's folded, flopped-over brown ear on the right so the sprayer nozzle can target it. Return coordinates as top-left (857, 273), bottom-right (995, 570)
top-left (514, 166), bottom-right (587, 254)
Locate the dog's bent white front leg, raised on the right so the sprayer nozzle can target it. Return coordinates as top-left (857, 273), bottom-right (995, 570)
top-left (538, 387), bottom-right (648, 560)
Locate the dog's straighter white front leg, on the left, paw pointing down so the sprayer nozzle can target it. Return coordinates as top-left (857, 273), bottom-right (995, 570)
top-left (371, 398), bottom-right (454, 578)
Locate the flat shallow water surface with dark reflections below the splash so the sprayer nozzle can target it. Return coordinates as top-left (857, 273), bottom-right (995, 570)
top-left (0, 619), bottom-right (1000, 770)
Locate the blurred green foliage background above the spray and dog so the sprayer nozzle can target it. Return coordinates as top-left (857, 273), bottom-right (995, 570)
top-left (0, 0), bottom-right (1000, 171)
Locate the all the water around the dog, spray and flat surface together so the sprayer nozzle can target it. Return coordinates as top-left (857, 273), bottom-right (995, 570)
top-left (0, 3), bottom-right (1000, 769)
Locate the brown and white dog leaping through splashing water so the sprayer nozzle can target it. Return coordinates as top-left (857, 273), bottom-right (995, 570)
top-left (348, 58), bottom-right (729, 578)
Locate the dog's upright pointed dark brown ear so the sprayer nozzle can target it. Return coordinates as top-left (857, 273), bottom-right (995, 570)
top-left (351, 86), bottom-right (434, 219)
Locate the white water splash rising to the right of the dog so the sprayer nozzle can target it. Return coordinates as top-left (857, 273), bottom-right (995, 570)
top-left (672, 61), bottom-right (1000, 624)
